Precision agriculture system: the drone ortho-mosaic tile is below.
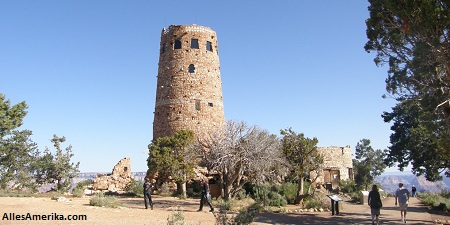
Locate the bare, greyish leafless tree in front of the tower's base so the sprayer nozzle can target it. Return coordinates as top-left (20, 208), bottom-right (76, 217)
top-left (200, 121), bottom-right (282, 199)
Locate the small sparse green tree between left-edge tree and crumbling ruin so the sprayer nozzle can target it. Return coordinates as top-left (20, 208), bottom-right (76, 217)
top-left (35, 134), bottom-right (80, 192)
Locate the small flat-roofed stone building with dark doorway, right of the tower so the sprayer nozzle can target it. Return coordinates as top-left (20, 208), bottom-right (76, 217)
top-left (316, 145), bottom-right (353, 189)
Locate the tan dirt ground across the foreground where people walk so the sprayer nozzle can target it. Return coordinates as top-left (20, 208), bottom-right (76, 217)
top-left (0, 196), bottom-right (450, 225)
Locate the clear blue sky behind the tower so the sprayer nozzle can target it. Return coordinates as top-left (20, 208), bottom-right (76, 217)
top-left (0, 0), bottom-right (396, 172)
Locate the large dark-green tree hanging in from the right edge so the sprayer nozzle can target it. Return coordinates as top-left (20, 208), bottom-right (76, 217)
top-left (365, 0), bottom-right (450, 181)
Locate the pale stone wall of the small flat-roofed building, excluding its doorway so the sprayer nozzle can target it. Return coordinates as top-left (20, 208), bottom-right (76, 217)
top-left (316, 145), bottom-right (353, 184)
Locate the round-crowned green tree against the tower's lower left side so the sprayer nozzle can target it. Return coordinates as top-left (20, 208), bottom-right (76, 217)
top-left (147, 130), bottom-right (197, 198)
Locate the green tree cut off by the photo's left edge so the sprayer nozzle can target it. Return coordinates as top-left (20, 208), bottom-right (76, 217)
top-left (0, 93), bottom-right (39, 190)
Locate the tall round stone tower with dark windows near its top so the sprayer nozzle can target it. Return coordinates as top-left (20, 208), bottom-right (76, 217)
top-left (153, 24), bottom-right (225, 139)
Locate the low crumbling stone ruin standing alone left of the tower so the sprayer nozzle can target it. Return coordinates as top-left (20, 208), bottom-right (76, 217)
top-left (93, 158), bottom-right (134, 191)
